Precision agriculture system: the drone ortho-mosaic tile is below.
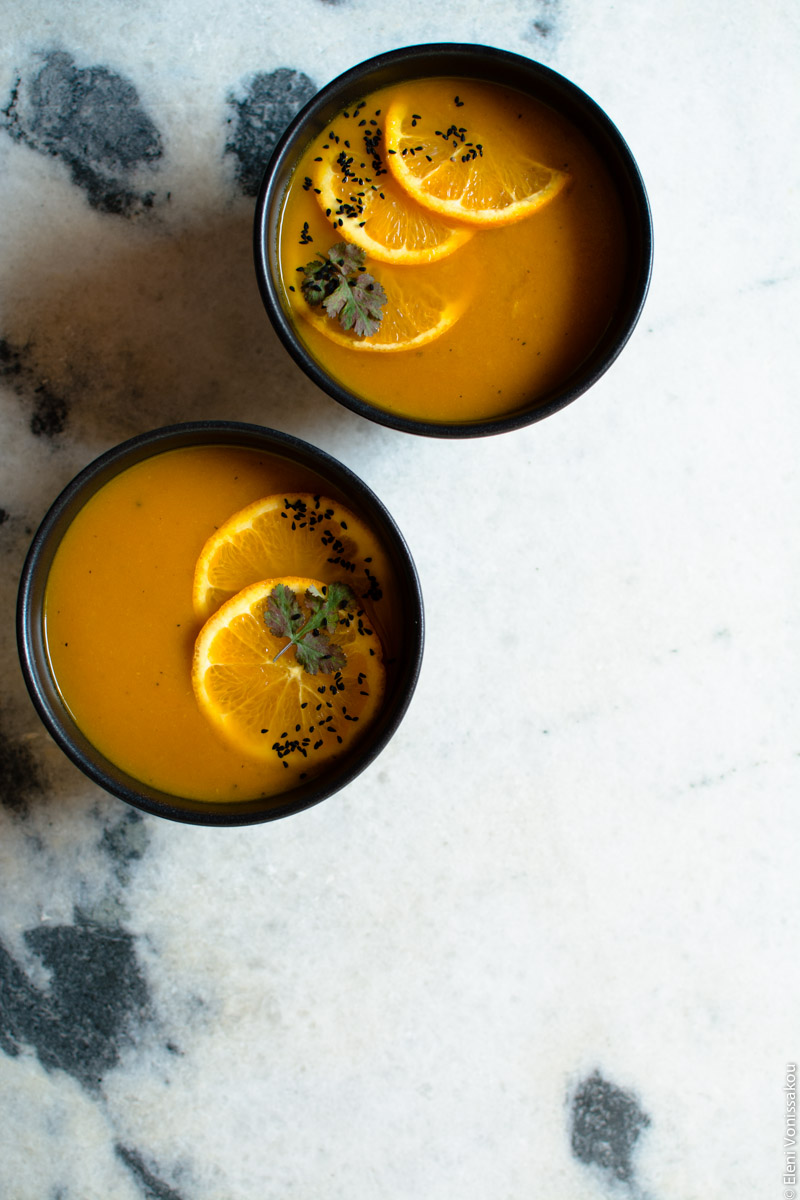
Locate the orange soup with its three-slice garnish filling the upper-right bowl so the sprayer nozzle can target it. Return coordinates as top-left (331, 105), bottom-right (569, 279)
top-left (278, 79), bottom-right (627, 422)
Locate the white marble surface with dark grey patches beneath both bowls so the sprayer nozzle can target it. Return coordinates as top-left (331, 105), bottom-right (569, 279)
top-left (0, 0), bottom-right (800, 1200)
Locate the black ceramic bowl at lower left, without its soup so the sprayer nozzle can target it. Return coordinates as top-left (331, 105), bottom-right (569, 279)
top-left (17, 421), bottom-right (423, 826)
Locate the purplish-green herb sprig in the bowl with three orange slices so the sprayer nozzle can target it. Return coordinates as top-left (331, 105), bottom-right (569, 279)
top-left (300, 241), bottom-right (386, 337)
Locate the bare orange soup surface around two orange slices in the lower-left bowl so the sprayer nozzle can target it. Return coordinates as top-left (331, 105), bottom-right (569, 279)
top-left (44, 446), bottom-right (392, 800)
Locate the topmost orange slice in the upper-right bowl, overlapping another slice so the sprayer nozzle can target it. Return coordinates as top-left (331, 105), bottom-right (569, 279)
top-left (385, 97), bottom-right (570, 227)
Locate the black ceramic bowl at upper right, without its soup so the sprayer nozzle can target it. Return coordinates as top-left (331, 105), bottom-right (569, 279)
top-left (254, 43), bottom-right (652, 438)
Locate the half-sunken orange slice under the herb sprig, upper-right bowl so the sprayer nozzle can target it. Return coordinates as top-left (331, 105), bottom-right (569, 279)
top-left (297, 263), bottom-right (470, 354)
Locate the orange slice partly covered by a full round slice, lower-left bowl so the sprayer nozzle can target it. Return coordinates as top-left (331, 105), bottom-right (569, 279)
top-left (192, 492), bottom-right (389, 620)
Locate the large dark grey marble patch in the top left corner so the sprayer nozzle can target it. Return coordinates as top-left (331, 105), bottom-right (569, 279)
top-left (0, 50), bottom-right (163, 217)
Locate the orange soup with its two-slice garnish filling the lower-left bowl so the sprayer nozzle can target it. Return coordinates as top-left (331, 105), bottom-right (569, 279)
top-left (44, 445), bottom-right (397, 800)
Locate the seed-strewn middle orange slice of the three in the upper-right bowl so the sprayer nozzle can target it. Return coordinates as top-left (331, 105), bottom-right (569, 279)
top-left (313, 112), bottom-right (473, 266)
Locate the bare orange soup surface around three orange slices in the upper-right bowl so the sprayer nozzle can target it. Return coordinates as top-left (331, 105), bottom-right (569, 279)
top-left (278, 79), bottom-right (627, 422)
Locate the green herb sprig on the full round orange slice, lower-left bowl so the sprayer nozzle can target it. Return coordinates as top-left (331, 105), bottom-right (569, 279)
top-left (264, 583), bottom-right (355, 674)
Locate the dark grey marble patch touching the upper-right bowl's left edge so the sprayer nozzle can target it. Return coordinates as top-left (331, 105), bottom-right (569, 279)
top-left (225, 67), bottom-right (317, 196)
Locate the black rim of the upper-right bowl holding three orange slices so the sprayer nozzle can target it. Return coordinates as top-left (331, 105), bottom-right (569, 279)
top-left (253, 42), bottom-right (654, 438)
